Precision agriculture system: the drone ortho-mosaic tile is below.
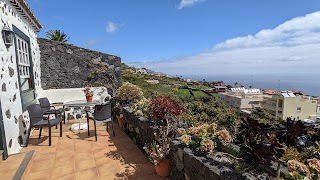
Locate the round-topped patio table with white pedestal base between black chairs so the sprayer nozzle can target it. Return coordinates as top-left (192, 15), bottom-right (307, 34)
top-left (64, 100), bottom-right (103, 133)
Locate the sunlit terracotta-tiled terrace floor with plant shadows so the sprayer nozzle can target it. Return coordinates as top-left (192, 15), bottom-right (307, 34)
top-left (0, 119), bottom-right (166, 180)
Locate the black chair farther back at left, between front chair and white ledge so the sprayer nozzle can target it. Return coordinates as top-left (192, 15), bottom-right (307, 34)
top-left (38, 97), bottom-right (66, 124)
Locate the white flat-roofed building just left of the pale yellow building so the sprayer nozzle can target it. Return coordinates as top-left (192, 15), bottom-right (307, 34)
top-left (218, 88), bottom-right (267, 110)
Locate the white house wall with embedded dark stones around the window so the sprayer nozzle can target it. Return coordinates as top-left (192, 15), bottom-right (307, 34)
top-left (0, 0), bottom-right (41, 154)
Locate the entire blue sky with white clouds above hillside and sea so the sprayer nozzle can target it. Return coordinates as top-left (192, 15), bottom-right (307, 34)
top-left (26, 0), bottom-right (320, 75)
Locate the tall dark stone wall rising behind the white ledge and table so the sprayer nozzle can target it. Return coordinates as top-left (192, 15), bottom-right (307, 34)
top-left (38, 38), bottom-right (121, 94)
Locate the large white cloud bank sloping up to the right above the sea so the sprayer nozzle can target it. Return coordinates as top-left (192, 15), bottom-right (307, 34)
top-left (129, 11), bottom-right (320, 75)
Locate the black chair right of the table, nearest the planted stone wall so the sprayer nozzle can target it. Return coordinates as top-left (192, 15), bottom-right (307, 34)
top-left (87, 103), bottom-right (115, 141)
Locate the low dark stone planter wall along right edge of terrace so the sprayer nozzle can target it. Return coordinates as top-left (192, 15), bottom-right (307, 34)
top-left (123, 107), bottom-right (256, 180)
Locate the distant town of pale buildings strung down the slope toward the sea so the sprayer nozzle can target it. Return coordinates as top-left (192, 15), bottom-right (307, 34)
top-left (131, 68), bottom-right (320, 125)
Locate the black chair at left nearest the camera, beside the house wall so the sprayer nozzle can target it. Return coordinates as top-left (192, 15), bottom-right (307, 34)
top-left (26, 104), bottom-right (63, 146)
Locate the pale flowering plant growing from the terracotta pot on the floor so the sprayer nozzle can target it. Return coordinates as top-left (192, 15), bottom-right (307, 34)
top-left (143, 126), bottom-right (172, 165)
